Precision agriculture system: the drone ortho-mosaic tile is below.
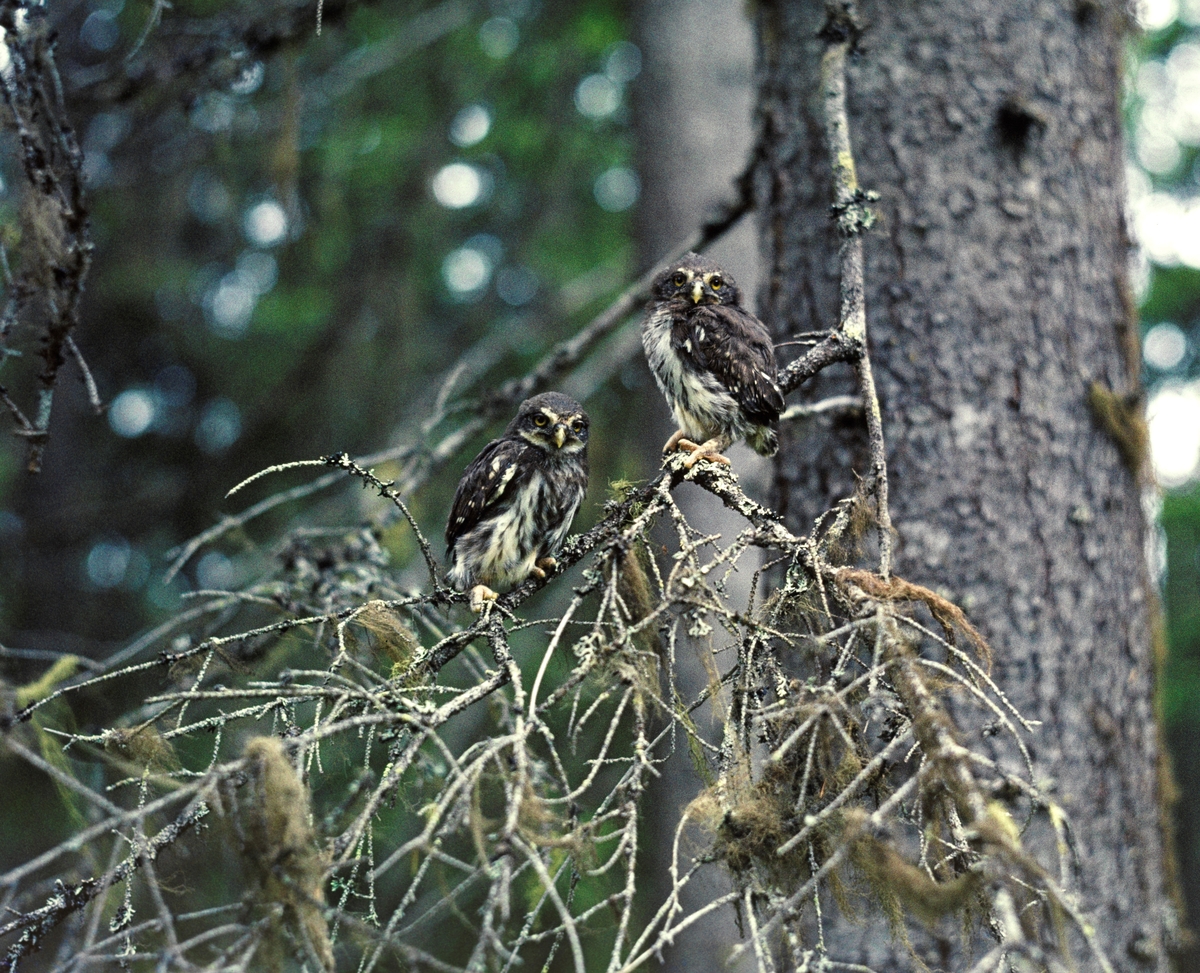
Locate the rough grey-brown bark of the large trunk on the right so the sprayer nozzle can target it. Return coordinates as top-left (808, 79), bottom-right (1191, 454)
top-left (757, 0), bottom-right (1174, 971)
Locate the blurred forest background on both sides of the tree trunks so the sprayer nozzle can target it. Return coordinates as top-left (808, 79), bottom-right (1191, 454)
top-left (0, 0), bottom-right (1200, 964)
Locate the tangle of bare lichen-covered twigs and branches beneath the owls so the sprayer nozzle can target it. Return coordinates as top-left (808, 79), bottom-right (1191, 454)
top-left (0, 429), bottom-right (1104, 972)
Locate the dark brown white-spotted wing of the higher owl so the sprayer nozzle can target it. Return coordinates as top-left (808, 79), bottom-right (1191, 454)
top-left (672, 305), bottom-right (784, 425)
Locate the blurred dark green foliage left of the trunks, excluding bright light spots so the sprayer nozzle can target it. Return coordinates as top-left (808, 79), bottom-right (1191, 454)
top-left (0, 0), bottom-right (632, 641)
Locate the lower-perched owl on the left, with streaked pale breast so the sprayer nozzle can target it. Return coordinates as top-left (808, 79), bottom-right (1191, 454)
top-left (446, 392), bottom-right (588, 612)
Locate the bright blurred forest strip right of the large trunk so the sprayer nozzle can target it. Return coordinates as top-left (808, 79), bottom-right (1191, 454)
top-left (1127, 0), bottom-right (1200, 935)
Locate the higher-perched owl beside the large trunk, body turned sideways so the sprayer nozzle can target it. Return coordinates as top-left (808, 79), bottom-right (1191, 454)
top-left (642, 253), bottom-right (784, 467)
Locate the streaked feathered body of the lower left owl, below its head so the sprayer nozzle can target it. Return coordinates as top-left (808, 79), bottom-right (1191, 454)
top-left (446, 436), bottom-right (588, 589)
